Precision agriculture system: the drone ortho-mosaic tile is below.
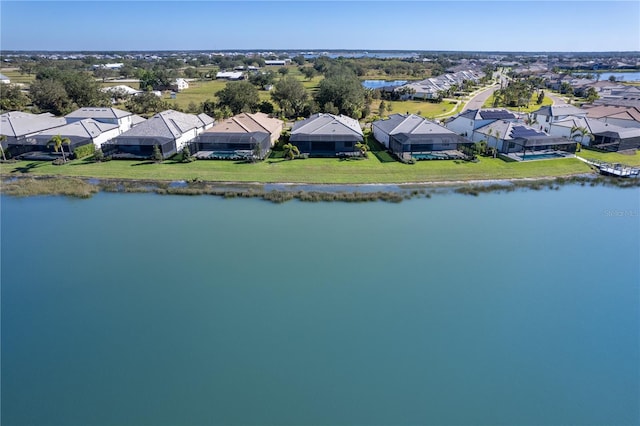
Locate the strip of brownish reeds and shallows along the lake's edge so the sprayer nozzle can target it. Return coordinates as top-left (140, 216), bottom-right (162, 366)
top-left (0, 174), bottom-right (640, 203)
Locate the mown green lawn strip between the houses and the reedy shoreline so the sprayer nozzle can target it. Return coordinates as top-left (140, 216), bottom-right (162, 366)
top-left (0, 154), bottom-right (590, 183)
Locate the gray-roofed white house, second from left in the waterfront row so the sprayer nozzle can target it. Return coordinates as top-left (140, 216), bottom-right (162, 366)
top-left (30, 118), bottom-right (120, 152)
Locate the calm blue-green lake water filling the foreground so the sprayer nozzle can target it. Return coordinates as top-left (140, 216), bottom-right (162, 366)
top-left (0, 186), bottom-right (640, 426)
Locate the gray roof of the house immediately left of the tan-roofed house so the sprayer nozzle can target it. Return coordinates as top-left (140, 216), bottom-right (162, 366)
top-left (118, 109), bottom-right (208, 139)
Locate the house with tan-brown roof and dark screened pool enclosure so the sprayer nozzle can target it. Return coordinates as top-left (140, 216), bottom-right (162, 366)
top-left (192, 112), bottom-right (284, 159)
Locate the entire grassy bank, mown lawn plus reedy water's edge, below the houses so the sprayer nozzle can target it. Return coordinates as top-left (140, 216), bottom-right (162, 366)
top-left (0, 150), bottom-right (640, 202)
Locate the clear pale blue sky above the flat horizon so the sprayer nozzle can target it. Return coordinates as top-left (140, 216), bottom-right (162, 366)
top-left (0, 0), bottom-right (640, 51)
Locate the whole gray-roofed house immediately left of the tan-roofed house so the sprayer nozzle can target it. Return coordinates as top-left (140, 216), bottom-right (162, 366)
top-left (102, 110), bottom-right (214, 158)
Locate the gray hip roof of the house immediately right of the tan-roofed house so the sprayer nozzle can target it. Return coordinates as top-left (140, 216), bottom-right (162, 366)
top-left (290, 113), bottom-right (363, 142)
